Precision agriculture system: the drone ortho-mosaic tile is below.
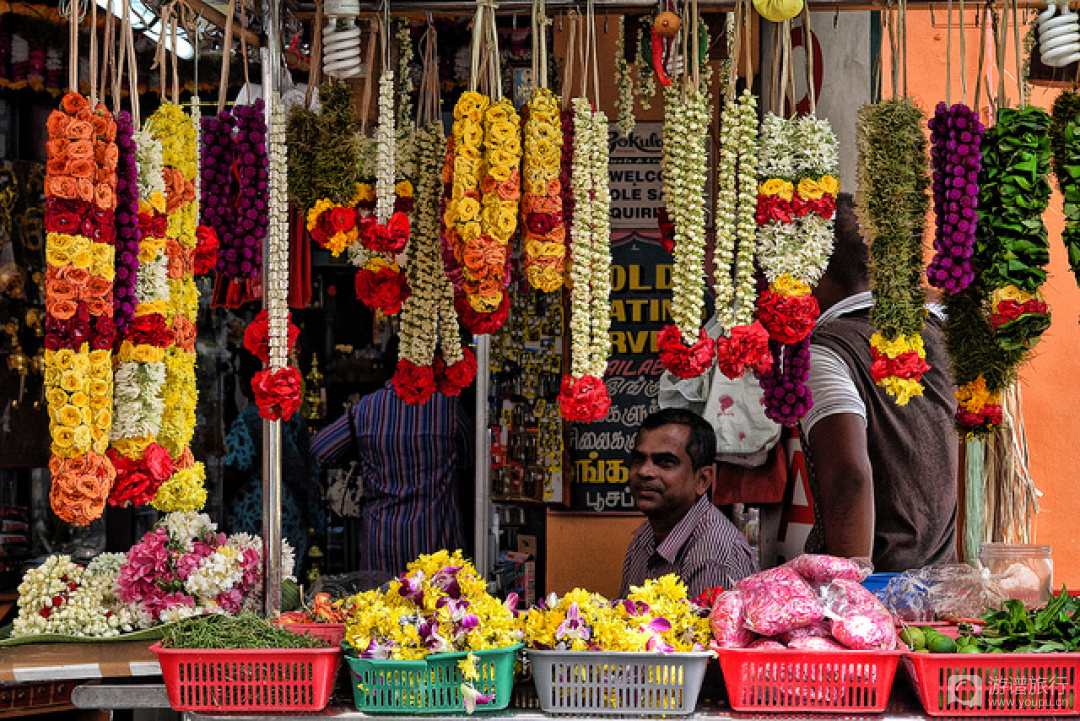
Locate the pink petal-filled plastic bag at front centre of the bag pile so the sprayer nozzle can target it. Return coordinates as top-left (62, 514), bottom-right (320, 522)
top-left (737, 566), bottom-right (825, 636)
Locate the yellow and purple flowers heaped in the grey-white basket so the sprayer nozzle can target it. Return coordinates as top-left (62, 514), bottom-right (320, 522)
top-left (522, 574), bottom-right (712, 653)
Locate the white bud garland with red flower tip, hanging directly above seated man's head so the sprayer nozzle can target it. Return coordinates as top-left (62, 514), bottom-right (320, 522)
top-left (658, 69), bottom-right (716, 378)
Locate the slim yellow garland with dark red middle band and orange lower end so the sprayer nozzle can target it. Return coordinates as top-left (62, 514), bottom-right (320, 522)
top-left (522, 87), bottom-right (566, 293)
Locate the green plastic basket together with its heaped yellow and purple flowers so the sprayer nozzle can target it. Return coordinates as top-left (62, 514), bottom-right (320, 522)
top-left (343, 550), bottom-right (522, 713)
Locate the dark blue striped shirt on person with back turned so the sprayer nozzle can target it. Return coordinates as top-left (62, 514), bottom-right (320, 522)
top-left (311, 358), bottom-right (472, 575)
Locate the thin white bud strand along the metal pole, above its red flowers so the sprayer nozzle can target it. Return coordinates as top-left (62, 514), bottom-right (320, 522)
top-left (264, 93), bottom-right (288, 371)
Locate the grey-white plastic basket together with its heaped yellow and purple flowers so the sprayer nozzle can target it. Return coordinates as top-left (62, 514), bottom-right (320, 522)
top-left (523, 575), bottom-right (713, 715)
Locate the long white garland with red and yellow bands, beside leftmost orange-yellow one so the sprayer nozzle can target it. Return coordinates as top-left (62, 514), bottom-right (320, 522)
top-left (108, 122), bottom-right (174, 506)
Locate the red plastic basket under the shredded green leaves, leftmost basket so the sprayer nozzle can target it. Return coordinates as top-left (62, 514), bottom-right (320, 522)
top-left (150, 643), bottom-right (341, 712)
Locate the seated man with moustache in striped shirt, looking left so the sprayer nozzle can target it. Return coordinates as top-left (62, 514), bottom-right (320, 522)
top-left (620, 408), bottom-right (757, 598)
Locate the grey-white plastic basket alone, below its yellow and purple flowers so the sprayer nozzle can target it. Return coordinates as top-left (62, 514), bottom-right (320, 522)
top-left (528, 651), bottom-right (713, 716)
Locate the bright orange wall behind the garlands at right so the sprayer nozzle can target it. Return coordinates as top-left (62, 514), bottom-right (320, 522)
top-left (886, 6), bottom-right (1080, 587)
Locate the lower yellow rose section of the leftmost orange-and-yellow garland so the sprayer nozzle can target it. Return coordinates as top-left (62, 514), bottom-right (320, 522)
top-left (45, 343), bottom-right (112, 458)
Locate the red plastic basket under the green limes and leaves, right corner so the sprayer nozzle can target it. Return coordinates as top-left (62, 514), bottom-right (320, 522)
top-left (904, 653), bottom-right (1080, 716)
